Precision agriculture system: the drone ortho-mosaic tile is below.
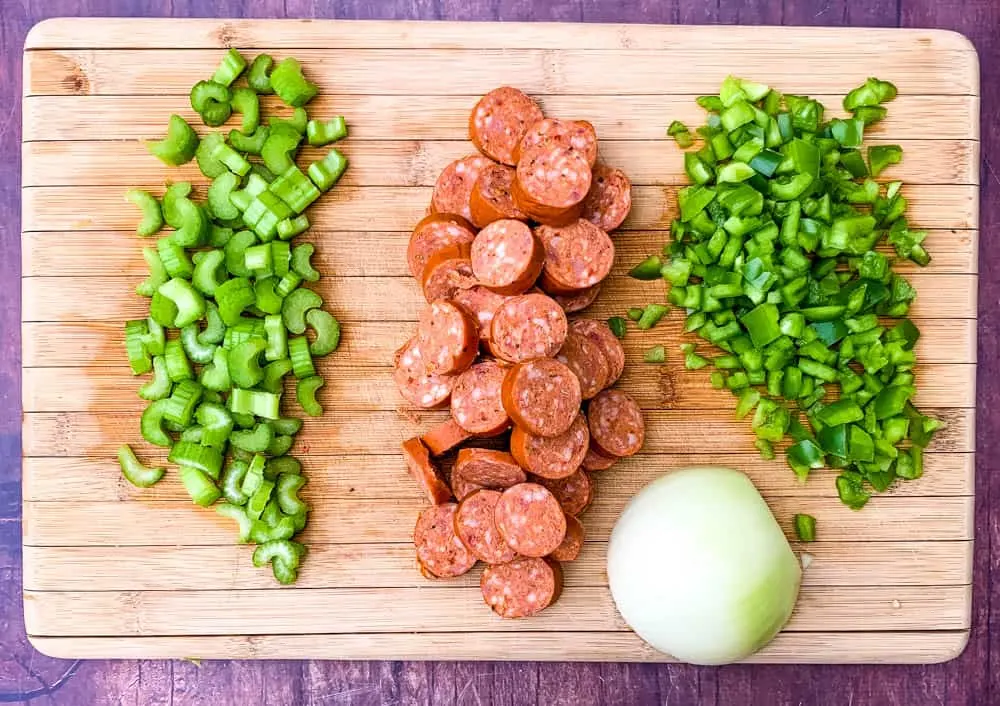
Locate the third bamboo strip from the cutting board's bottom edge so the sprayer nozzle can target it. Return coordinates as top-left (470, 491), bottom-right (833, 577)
top-left (24, 540), bottom-right (972, 592)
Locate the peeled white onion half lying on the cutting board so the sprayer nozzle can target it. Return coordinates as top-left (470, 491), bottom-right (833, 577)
top-left (608, 467), bottom-right (802, 664)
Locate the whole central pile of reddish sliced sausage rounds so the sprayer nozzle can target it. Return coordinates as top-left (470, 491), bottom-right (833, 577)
top-left (394, 87), bottom-right (645, 618)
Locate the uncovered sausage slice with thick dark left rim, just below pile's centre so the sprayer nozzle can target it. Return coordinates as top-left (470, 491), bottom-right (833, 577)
top-left (502, 358), bottom-right (583, 436)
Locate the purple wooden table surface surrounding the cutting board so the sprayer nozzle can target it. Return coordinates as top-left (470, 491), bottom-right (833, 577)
top-left (0, 0), bottom-right (1000, 706)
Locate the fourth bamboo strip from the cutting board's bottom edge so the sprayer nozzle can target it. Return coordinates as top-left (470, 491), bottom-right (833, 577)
top-left (24, 496), bottom-right (973, 544)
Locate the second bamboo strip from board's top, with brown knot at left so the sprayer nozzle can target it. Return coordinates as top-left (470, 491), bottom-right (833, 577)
top-left (24, 46), bottom-right (979, 98)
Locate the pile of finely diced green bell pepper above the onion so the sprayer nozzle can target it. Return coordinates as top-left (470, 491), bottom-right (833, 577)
top-left (621, 77), bottom-right (941, 512)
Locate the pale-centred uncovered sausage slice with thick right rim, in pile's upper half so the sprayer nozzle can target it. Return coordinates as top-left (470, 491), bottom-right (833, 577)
top-left (471, 219), bottom-right (545, 294)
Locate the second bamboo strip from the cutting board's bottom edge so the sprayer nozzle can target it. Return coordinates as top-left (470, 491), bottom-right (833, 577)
top-left (24, 580), bottom-right (969, 637)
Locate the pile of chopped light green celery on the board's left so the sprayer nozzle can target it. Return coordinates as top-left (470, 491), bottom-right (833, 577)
top-left (118, 49), bottom-right (347, 584)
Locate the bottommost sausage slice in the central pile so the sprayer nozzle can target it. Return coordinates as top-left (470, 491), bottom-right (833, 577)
top-left (479, 557), bottom-right (562, 618)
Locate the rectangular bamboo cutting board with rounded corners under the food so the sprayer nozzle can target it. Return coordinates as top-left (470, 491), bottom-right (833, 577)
top-left (23, 19), bottom-right (979, 662)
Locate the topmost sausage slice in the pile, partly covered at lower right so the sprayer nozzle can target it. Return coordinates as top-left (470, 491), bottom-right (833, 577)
top-left (469, 86), bottom-right (543, 164)
